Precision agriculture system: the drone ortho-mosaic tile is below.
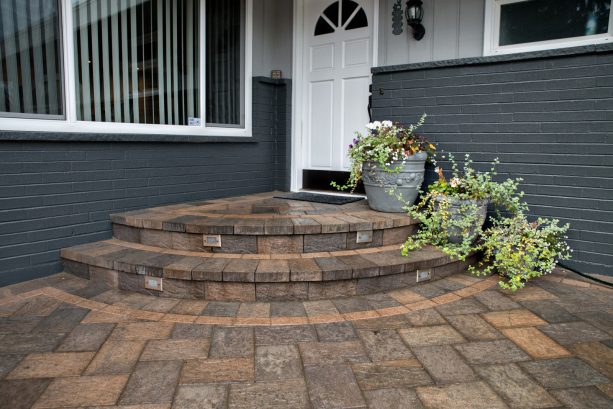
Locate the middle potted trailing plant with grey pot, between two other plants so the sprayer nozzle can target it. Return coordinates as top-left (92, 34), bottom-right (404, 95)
top-left (402, 155), bottom-right (527, 260)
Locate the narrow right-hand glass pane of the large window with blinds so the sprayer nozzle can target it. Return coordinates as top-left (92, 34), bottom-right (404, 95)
top-left (206, 0), bottom-right (245, 126)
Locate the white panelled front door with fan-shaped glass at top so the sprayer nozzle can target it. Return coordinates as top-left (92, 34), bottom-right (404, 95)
top-left (302, 0), bottom-right (375, 171)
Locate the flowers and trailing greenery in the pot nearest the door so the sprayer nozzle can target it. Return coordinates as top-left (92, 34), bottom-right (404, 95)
top-left (330, 114), bottom-right (436, 193)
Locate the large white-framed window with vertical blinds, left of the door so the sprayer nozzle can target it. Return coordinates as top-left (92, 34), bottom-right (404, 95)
top-left (0, 0), bottom-right (251, 136)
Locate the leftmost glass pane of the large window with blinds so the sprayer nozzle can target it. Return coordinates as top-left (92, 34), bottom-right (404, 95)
top-left (0, 0), bottom-right (64, 116)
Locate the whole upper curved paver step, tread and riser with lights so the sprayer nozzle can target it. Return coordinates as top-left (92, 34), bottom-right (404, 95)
top-left (111, 193), bottom-right (417, 254)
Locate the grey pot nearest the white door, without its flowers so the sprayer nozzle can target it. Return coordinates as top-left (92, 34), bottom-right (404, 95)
top-left (362, 152), bottom-right (428, 213)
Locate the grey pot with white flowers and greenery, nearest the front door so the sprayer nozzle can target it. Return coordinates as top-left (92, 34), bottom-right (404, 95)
top-left (331, 114), bottom-right (436, 212)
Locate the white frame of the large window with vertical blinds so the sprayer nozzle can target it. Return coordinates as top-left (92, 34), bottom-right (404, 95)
top-left (0, 0), bottom-right (253, 137)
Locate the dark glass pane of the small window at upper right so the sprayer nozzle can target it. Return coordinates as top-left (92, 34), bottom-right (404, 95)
top-left (499, 0), bottom-right (611, 46)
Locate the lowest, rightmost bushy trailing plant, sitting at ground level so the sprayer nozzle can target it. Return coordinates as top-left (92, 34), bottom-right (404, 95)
top-left (469, 213), bottom-right (572, 291)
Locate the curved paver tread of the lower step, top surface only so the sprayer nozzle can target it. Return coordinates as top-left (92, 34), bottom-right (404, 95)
top-left (61, 240), bottom-right (459, 283)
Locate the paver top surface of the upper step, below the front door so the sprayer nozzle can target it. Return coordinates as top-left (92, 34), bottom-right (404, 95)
top-left (111, 196), bottom-right (417, 235)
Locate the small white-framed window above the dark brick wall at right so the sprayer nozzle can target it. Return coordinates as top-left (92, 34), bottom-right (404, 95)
top-left (484, 0), bottom-right (613, 55)
